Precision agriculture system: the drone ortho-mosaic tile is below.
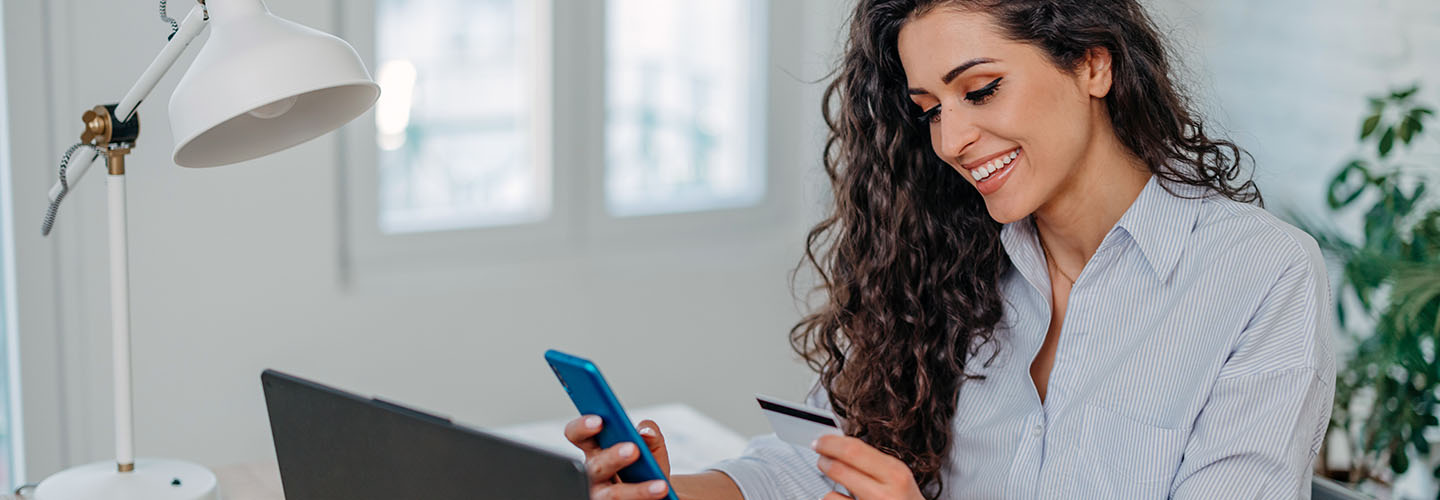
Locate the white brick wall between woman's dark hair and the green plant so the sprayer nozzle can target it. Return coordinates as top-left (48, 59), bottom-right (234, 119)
top-left (1146, 0), bottom-right (1440, 213)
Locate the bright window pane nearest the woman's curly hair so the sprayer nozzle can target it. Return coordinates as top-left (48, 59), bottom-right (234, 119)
top-left (605, 0), bottom-right (765, 215)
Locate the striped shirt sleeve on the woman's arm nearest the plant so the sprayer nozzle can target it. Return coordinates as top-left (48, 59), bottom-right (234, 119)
top-left (1171, 242), bottom-right (1335, 499)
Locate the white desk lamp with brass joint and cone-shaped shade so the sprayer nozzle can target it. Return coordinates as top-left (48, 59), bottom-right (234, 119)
top-left (35, 0), bottom-right (380, 500)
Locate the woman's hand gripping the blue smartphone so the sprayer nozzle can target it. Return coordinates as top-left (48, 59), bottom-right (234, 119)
top-left (564, 415), bottom-right (670, 500)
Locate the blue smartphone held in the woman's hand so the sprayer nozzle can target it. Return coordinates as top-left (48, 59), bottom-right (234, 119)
top-left (544, 349), bottom-right (680, 500)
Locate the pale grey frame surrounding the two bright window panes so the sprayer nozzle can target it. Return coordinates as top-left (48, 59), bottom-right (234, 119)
top-left (337, 0), bottom-right (819, 287)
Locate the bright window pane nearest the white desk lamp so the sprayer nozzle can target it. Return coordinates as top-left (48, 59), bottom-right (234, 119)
top-left (374, 0), bottom-right (550, 233)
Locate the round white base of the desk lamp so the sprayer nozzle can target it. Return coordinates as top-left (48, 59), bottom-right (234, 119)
top-left (35, 460), bottom-right (220, 500)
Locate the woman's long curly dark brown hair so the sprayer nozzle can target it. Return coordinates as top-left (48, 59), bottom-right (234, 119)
top-left (789, 0), bottom-right (1263, 499)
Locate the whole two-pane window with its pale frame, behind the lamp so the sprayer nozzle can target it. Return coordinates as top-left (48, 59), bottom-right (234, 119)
top-left (345, 0), bottom-right (800, 273)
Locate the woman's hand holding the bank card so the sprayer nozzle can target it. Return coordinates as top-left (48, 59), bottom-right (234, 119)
top-left (814, 435), bottom-right (924, 500)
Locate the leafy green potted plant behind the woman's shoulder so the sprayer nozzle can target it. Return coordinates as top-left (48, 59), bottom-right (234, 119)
top-left (1290, 86), bottom-right (1440, 495)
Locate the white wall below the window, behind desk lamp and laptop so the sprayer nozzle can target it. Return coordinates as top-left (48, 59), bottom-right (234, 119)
top-left (4, 0), bottom-right (844, 480)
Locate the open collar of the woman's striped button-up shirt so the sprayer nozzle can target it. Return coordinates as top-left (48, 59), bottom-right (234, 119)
top-left (999, 176), bottom-right (1207, 290)
